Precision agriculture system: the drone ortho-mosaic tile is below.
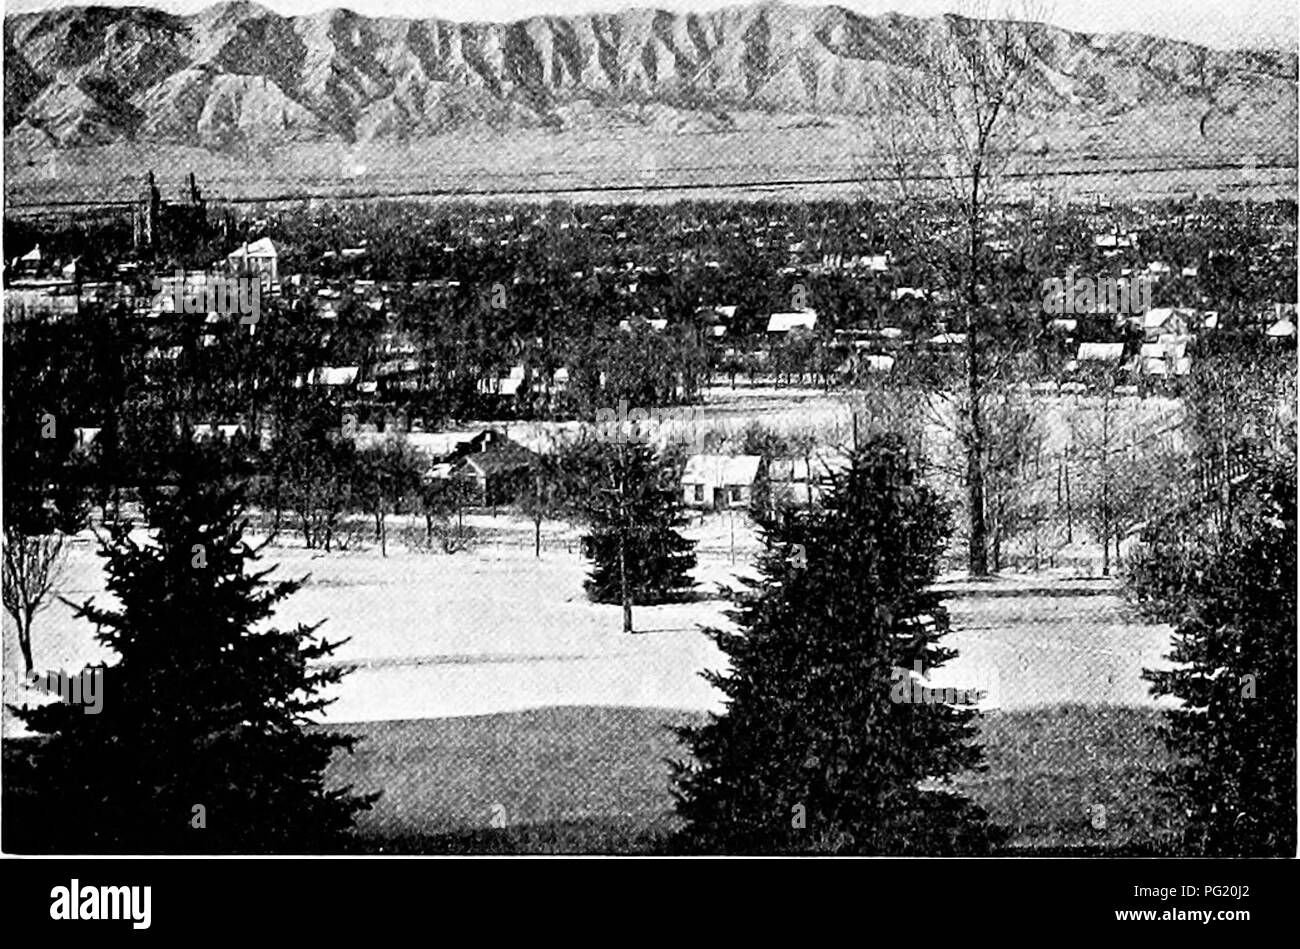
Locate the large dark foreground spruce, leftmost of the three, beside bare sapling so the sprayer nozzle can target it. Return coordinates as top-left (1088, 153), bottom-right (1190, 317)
top-left (7, 465), bottom-right (373, 853)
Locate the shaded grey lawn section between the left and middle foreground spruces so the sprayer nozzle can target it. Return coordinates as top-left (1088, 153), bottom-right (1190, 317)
top-left (329, 707), bottom-right (699, 853)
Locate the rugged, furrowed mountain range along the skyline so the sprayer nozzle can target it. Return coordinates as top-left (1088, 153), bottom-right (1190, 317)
top-left (4, 0), bottom-right (1296, 152)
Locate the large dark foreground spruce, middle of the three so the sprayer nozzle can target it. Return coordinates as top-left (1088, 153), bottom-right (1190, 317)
top-left (673, 436), bottom-right (993, 854)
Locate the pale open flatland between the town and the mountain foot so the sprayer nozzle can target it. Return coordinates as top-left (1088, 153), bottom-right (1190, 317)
top-left (5, 116), bottom-right (1296, 212)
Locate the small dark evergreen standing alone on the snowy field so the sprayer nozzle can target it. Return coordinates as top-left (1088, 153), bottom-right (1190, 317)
top-left (582, 442), bottom-right (696, 605)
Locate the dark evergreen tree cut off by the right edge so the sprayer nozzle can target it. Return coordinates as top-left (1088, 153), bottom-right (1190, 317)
top-left (1130, 455), bottom-right (1296, 857)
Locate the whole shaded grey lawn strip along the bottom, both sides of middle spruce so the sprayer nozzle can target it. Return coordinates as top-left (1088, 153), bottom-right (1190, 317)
top-left (319, 706), bottom-right (1179, 855)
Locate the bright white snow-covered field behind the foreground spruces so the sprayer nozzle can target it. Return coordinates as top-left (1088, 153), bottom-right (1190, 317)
top-left (4, 506), bottom-right (1169, 733)
